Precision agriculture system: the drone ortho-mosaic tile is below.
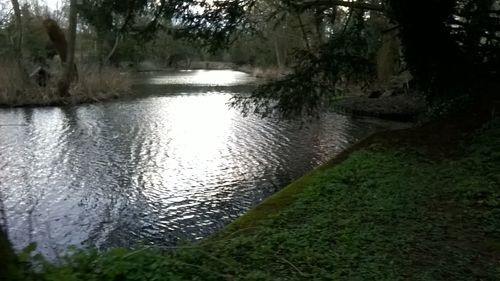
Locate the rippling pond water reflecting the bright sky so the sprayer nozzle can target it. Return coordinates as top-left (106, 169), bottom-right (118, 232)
top-left (0, 71), bottom-right (402, 257)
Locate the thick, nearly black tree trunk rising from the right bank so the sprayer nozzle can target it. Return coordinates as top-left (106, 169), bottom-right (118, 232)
top-left (388, 0), bottom-right (464, 95)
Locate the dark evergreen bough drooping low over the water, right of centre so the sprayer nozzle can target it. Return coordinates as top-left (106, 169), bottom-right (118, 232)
top-left (231, 13), bottom-right (374, 118)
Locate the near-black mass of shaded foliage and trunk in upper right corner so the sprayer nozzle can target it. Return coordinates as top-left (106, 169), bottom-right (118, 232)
top-left (388, 0), bottom-right (500, 98)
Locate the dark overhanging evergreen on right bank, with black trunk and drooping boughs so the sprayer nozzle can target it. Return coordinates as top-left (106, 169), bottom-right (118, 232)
top-left (178, 0), bottom-right (500, 115)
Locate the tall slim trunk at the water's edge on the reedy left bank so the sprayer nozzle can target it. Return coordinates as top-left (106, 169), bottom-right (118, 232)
top-left (58, 0), bottom-right (77, 96)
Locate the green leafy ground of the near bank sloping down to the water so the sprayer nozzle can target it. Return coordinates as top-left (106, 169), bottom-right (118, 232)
top-left (9, 119), bottom-right (500, 280)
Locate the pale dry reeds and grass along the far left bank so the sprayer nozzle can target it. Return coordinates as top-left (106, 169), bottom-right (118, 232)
top-left (0, 64), bottom-right (131, 107)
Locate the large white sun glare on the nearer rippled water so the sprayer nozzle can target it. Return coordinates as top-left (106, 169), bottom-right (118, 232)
top-left (131, 94), bottom-right (242, 212)
